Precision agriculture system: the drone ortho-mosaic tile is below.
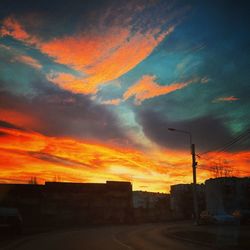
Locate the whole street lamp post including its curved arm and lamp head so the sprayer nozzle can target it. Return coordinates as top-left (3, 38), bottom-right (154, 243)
top-left (168, 128), bottom-right (199, 225)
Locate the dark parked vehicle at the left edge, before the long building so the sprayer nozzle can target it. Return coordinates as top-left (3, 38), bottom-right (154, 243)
top-left (0, 207), bottom-right (23, 234)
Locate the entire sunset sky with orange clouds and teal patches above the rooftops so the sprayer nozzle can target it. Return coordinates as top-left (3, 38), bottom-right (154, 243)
top-left (0, 0), bottom-right (250, 192)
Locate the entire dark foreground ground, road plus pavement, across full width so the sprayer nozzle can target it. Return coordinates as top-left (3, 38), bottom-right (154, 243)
top-left (1, 222), bottom-right (250, 250)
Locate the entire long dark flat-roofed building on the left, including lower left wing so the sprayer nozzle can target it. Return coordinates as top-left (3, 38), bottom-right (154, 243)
top-left (0, 181), bottom-right (133, 225)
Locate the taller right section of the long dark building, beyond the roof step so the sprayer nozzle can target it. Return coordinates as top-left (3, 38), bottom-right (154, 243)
top-left (43, 181), bottom-right (132, 223)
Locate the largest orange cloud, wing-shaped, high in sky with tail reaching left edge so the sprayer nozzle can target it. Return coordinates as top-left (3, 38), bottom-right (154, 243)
top-left (0, 17), bottom-right (174, 94)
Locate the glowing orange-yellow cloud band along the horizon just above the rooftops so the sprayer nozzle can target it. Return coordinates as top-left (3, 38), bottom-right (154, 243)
top-left (0, 128), bottom-right (250, 192)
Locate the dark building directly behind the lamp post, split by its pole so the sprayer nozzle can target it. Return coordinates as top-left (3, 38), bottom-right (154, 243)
top-left (170, 184), bottom-right (205, 219)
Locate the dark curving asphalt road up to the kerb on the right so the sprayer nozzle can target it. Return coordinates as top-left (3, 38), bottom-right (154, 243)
top-left (3, 224), bottom-right (213, 250)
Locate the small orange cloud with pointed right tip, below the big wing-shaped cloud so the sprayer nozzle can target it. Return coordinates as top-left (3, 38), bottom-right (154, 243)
top-left (123, 75), bottom-right (193, 104)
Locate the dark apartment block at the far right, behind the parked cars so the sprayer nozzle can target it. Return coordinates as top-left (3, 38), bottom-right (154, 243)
top-left (205, 177), bottom-right (250, 214)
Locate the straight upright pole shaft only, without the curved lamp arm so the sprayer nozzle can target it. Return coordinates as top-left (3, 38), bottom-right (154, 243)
top-left (191, 143), bottom-right (199, 225)
